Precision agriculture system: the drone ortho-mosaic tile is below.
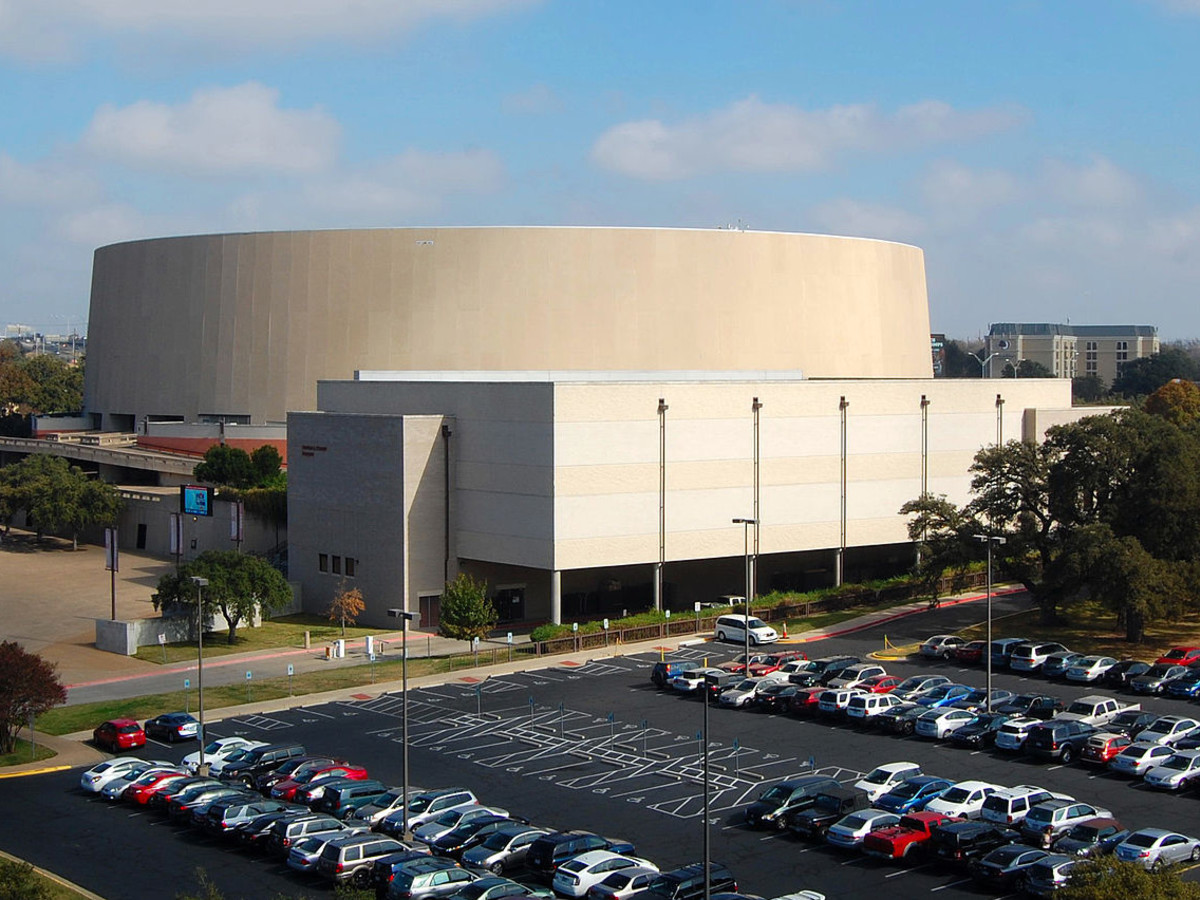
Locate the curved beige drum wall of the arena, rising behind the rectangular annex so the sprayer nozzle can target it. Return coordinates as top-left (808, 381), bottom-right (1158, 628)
top-left (84, 227), bottom-right (931, 427)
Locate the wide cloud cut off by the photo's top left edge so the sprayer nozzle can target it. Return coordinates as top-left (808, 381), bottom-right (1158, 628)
top-left (0, 0), bottom-right (541, 61)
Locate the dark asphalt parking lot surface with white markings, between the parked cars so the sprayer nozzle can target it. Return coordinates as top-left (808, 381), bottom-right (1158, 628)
top-left (0, 592), bottom-right (1200, 899)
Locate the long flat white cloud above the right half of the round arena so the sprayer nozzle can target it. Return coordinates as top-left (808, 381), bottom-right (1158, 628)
top-left (592, 96), bottom-right (1024, 180)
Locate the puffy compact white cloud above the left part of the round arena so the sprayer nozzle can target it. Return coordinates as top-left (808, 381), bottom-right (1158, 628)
top-left (82, 83), bottom-right (341, 175)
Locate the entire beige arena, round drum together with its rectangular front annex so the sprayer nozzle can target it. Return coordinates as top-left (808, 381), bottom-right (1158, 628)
top-left (85, 228), bottom-right (1094, 626)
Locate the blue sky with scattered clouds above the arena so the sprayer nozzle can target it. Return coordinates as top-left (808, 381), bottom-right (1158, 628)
top-left (0, 0), bottom-right (1200, 340)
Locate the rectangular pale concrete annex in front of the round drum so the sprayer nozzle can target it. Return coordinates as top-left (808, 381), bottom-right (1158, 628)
top-left (288, 372), bottom-right (1084, 624)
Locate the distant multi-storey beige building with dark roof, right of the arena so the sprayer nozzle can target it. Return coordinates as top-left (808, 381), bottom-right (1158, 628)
top-left (985, 322), bottom-right (1159, 384)
